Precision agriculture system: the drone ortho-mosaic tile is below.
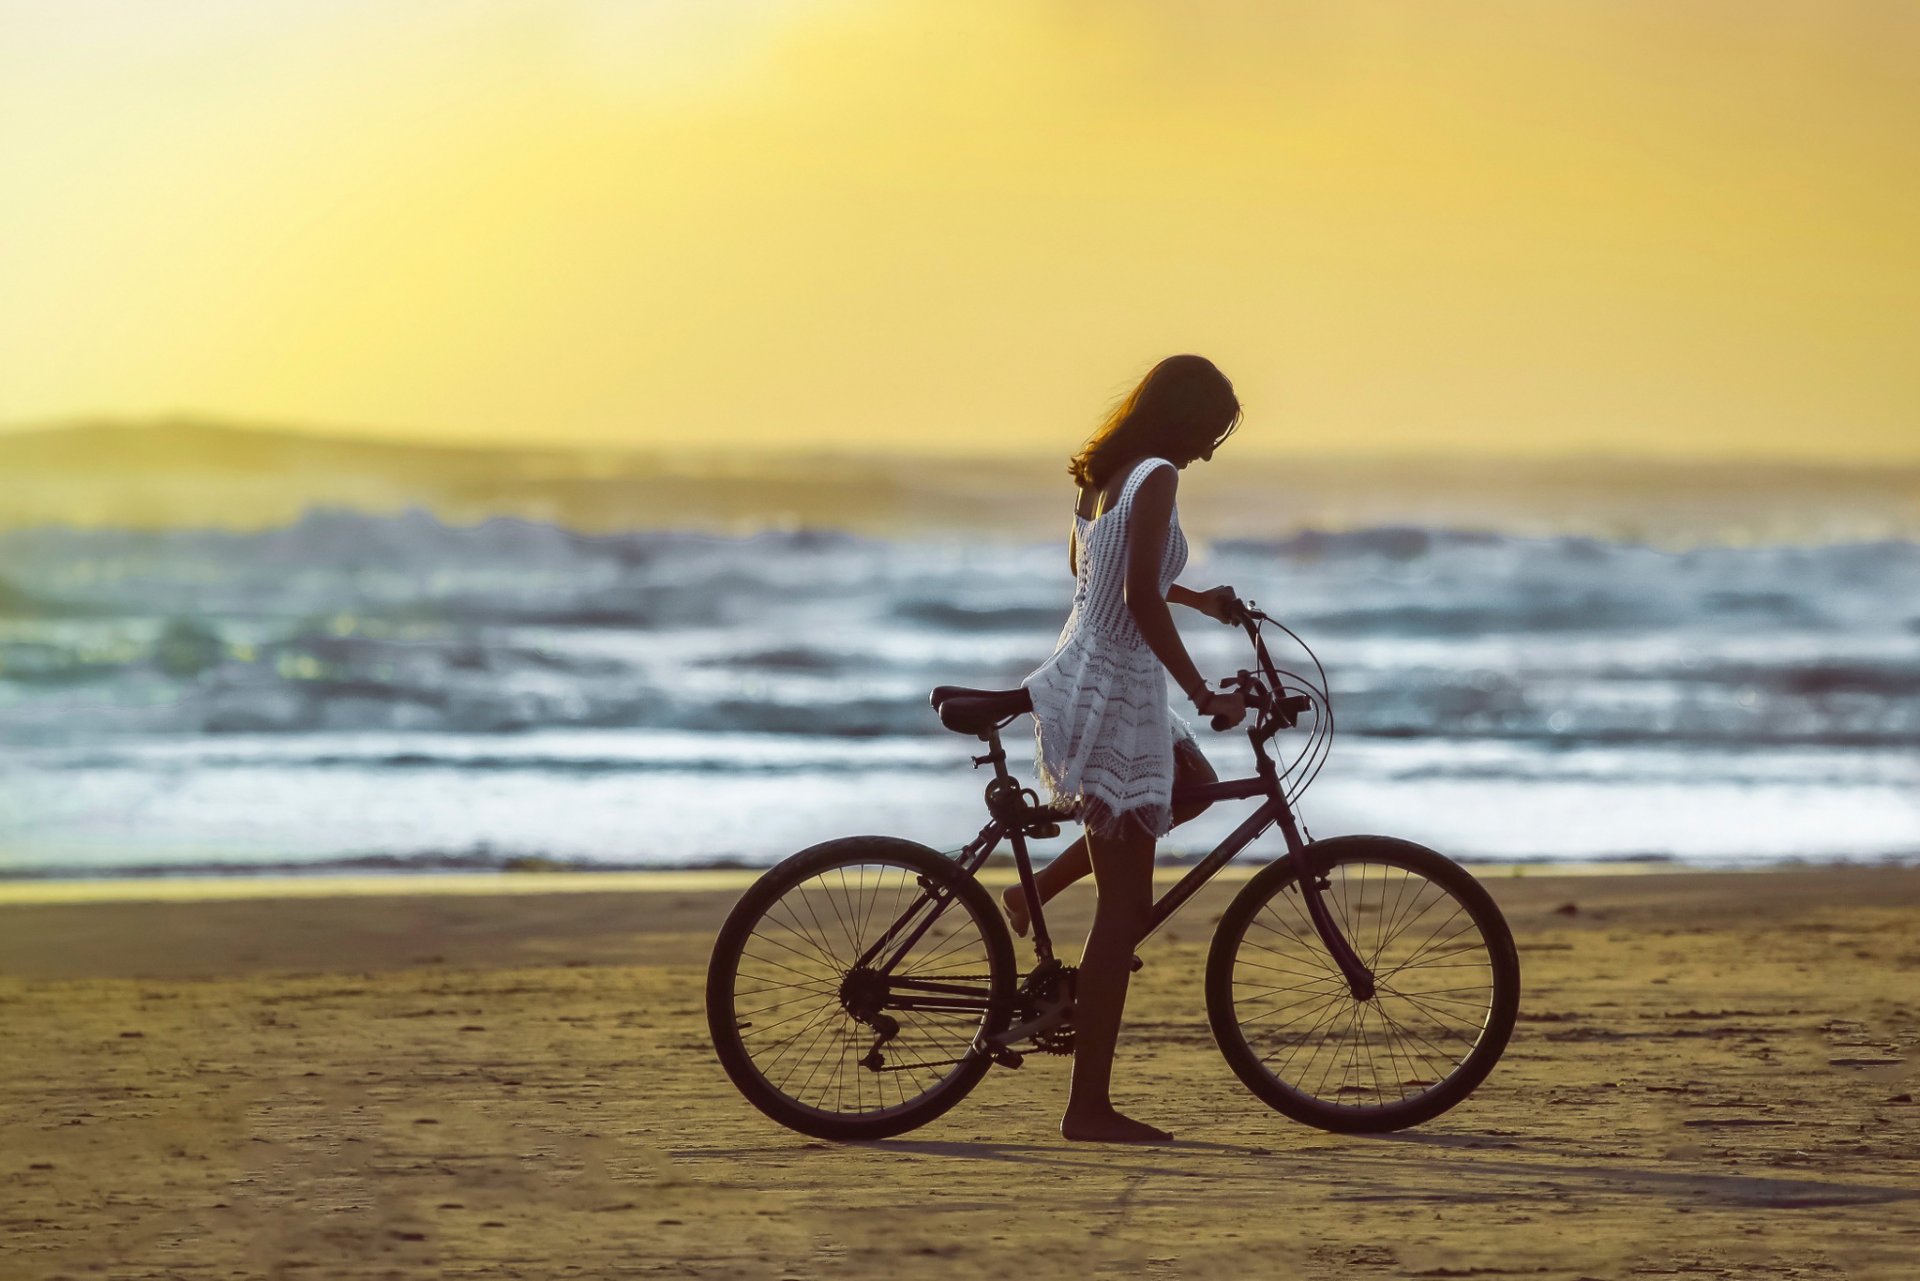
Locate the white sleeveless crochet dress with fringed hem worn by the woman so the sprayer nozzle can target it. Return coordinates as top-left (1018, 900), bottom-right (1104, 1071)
top-left (1020, 459), bottom-right (1192, 837)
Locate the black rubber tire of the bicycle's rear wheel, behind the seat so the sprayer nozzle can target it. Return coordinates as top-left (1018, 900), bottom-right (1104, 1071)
top-left (707, 835), bottom-right (1016, 1141)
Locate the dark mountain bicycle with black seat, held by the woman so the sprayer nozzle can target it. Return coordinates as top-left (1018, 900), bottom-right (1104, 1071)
top-left (707, 603), bottom-right (1521, 1139)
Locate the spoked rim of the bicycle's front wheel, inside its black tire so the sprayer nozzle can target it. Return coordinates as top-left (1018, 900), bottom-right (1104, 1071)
top-left (1233, 857), bottom-right (1498, 1116)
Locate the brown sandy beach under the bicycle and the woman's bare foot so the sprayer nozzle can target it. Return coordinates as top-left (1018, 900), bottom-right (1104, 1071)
top-left (0, 868), bottom-right (1920, 1281)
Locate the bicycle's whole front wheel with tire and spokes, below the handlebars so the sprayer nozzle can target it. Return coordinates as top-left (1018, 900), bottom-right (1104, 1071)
top-left (1206, 835), bottom-right (1521, 1133)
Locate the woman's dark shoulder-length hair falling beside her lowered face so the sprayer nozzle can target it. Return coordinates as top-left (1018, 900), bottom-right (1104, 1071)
top-left (1068, 355), bottom-right (1240, 488)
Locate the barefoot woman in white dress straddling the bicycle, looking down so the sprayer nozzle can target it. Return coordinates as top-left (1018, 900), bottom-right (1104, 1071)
top-left (1004, 355), bottom-right (1246, 1143)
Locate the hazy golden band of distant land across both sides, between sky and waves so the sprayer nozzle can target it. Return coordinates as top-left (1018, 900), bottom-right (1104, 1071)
top-left (0, 421), bottom-right (1920, 544)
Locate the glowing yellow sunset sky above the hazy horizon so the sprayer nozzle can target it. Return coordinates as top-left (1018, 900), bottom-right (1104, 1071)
top-left (0, 0), bottom-right (1920, 459)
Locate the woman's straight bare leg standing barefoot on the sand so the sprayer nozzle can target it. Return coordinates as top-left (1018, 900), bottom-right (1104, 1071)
top-left (1060, 810), bottom-right (1171, 1143)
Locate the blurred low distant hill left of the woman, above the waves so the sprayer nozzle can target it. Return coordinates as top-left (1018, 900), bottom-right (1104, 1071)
top-left (0, 421), bottom-right (1064, 532)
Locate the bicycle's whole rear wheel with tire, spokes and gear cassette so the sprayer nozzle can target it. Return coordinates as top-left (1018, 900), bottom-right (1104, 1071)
top-left (707, 835), bottom-right (1014, 1139)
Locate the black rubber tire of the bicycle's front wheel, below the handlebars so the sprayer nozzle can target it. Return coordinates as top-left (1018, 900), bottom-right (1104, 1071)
top-left (1206, 835), bottom-right (1521, 1133)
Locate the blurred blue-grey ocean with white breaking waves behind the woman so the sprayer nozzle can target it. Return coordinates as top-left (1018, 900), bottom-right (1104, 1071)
top-left (0, 509), bottom-right (1920, 878)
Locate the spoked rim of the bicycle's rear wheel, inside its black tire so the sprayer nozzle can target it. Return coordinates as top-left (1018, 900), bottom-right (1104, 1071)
top-left (732, 858), bottom-right (993, 1120)
